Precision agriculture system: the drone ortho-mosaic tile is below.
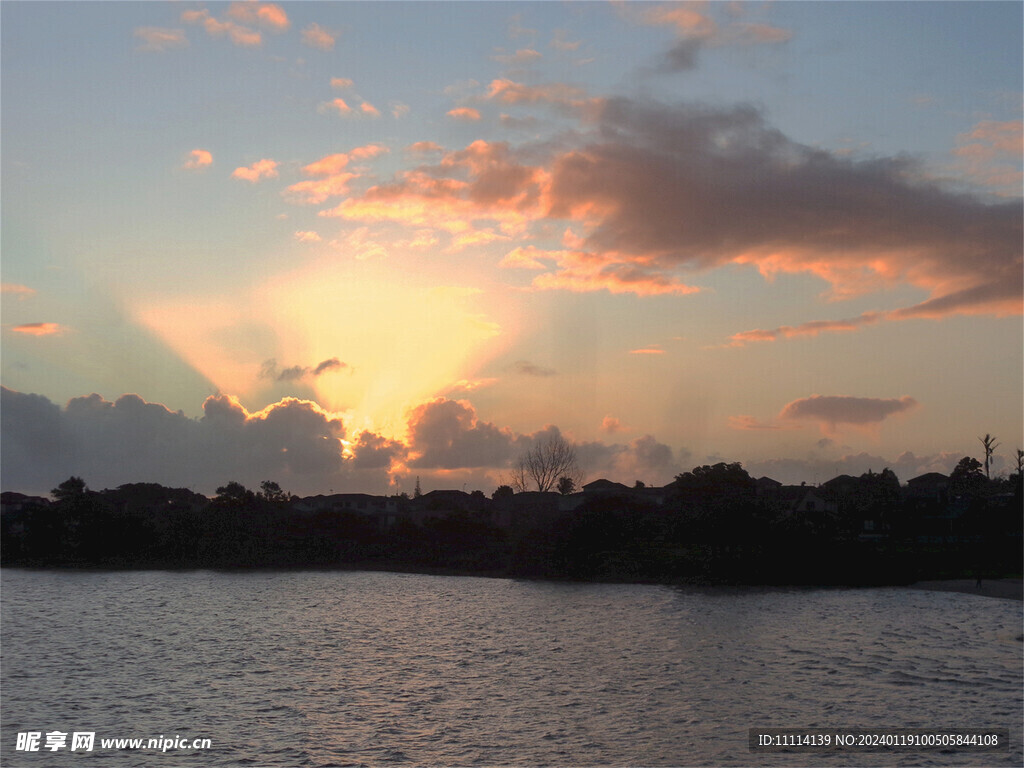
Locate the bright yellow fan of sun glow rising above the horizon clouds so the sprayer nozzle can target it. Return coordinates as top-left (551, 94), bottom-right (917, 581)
top-left (136, 260), bottom-right (511, 438)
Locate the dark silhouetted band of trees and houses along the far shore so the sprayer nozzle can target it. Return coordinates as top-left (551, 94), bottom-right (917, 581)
top-left (0, 458), bottom-right (1022, 584)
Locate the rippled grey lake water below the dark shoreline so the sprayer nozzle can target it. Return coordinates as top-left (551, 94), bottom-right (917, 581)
top-left (0, 569), bottom-right (1024, 768)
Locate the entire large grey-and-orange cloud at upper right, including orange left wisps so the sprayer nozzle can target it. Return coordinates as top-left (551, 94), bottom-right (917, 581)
top-left (322, 93), bottom-right (1024, 313)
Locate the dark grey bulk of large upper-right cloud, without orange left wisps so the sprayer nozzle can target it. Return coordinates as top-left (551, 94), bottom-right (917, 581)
top-left (546, 98), bottom-right (1022, 319)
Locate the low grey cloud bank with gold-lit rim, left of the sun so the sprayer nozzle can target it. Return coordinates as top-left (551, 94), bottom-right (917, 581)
top-left (0, 388), bottom-right (348, 494)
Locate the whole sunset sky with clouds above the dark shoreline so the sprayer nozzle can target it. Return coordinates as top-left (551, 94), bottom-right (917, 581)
top-left (0, 0), bottom-right (1024, 495)
